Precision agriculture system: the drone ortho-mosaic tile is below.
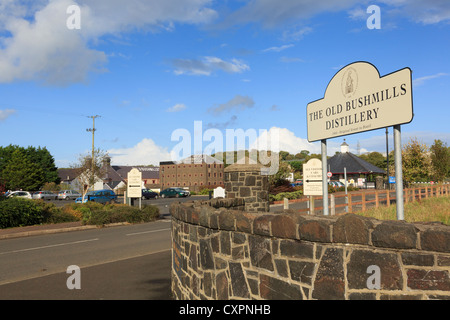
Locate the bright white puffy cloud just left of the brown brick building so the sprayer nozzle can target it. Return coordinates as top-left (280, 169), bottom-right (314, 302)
top-left (108, 138), bottom-right (171, 166)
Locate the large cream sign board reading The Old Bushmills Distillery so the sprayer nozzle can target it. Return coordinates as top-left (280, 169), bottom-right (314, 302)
top-left (306, 62), bottom-right (413, 142)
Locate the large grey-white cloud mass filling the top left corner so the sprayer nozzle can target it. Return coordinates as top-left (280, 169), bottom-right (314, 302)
top-left (0, 0), bottom-right (217, 85)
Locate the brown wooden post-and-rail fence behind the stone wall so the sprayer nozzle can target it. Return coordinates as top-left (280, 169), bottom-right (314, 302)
top-left (274, 184), bottom-right (450, 215)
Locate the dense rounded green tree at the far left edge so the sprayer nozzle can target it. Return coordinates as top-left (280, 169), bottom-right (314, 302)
top-left (1, 149), bottom-right (45, 191)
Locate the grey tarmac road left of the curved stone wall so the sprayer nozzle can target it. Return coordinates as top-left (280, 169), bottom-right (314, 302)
top-left (0, 220), bottom-right (171, 300)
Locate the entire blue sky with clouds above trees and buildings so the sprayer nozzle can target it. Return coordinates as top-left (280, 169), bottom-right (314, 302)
top-left (0, 0), bottom-right (450, 167)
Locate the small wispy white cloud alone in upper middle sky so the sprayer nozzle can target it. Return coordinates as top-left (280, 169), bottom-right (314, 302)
top-left (172, 57), bottom-right (250, 76)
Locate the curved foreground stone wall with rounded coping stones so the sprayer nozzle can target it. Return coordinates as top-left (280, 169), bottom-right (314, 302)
top-left (171, 199), bottom-right (450, 300)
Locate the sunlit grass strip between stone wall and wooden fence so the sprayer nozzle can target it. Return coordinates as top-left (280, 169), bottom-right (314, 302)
top-left (355, 197), bottom-right (450, 225)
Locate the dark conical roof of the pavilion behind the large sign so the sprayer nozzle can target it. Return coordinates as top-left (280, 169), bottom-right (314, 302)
top-left (328, 152), bottom-right (386, 174)
